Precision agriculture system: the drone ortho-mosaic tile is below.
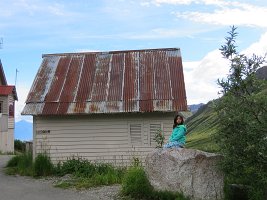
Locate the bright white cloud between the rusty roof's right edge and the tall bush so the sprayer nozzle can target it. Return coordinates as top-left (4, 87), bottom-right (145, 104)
top-left (183, 50), bottom-right (229, 105)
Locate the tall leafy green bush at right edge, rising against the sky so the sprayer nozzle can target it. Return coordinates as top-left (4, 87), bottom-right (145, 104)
top-left (216, 27), bottom-right (267, 199)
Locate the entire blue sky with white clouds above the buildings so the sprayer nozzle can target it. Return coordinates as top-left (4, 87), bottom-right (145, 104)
top-left (0, 0), bottom-right (267, 121)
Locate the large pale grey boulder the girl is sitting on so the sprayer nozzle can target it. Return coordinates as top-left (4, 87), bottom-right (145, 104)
top-left (145, 148), bottom-right (224, 200)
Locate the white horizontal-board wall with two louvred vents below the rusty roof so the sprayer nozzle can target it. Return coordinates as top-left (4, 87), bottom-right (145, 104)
top-left (33, 113), bottom-right (174, 165)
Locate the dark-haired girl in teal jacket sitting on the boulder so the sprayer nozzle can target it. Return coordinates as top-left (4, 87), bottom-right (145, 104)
top-left (163, 115), bottom-right (186, 149)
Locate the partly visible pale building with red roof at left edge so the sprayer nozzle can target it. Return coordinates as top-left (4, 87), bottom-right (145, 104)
top-left (0, 60), bottom-right (18, 153)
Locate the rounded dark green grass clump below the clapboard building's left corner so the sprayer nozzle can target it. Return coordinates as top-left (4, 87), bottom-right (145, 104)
top-left (34, 154), bottom-right (54, 176)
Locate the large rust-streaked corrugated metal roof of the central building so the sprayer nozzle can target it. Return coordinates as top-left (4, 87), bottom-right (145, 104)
top-left (22, 48), bottom-right (187, 115)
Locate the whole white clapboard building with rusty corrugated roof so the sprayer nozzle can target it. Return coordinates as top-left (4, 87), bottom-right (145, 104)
top-left (22, 48), bottom-right (187, 165)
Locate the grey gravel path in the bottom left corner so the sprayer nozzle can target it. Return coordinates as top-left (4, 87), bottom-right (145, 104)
top-left (0, 155), bottom-right (120, 200)
